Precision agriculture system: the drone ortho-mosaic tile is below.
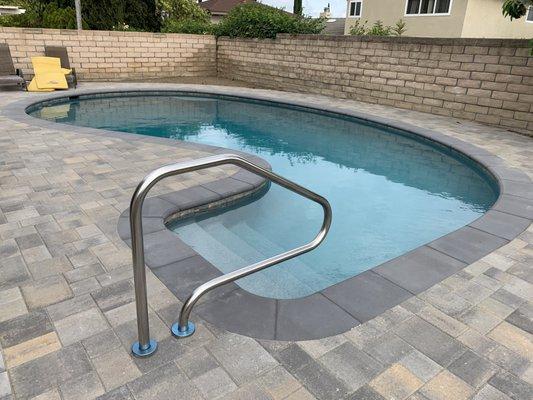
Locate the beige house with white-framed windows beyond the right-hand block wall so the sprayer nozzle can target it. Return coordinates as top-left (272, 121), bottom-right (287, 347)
top-left (344, 0), bottom-right (533, 39)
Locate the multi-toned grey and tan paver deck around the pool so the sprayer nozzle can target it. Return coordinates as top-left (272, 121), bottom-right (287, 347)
top-left (0, 83), bottom-right (533, 400)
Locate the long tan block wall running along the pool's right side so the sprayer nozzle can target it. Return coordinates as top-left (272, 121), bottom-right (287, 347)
top-left (217, 35), bottom-right (533, 134)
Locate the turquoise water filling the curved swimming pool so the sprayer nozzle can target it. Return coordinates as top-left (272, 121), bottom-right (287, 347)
top-left (30, 95), bottom-right (498, 299)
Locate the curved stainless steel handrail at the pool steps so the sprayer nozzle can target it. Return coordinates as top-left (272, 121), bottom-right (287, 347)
top-left (130, 154), bottom-right (332, 357)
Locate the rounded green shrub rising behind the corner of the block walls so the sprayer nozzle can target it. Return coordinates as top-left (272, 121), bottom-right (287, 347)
top-left (213, 3), bottom-right (325, 39)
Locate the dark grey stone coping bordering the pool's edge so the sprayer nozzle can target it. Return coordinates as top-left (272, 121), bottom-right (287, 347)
top-left (2, 85), bottom-right (533, 340)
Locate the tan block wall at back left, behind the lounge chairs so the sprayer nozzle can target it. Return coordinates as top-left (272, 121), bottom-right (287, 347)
top-left (0, 27), bottom-right (216, 80)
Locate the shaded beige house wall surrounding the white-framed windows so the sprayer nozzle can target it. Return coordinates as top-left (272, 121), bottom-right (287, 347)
top-left (345, 0), bottom-right (468, 38)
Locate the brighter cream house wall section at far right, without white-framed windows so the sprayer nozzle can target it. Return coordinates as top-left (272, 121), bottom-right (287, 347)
top-left (461, 0), bottom-right (533, 39)
